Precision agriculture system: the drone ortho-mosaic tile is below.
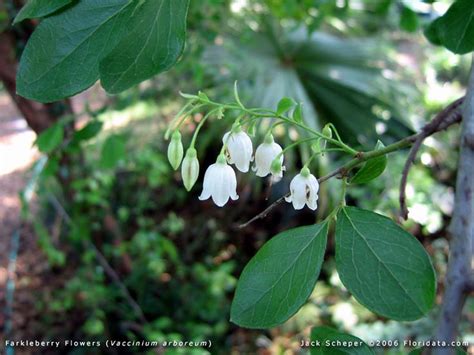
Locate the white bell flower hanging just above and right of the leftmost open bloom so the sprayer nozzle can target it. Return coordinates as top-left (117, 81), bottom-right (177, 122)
top-left (222, 127), bottom-right (253, 173)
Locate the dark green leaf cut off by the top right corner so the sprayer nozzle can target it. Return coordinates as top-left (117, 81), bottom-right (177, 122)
top-left (425, 0), bottom-right (474, 54)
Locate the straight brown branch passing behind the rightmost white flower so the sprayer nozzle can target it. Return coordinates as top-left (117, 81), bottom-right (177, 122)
top-left (239, 98), bottom-right (463, 228)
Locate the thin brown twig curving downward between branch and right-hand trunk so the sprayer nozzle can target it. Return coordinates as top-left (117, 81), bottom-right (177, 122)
top-left (399, 97), bottom-right (464, 220)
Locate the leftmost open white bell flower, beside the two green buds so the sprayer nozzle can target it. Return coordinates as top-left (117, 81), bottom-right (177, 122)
top-left (199, 154), bottom-right (239, 207)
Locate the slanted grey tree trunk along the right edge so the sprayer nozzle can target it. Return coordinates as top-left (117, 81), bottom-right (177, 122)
top-left (432, 57), bottom-right (474, 355)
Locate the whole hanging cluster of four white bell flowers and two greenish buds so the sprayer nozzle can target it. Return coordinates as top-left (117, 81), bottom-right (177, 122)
top-left (168, 123), bottom-right (319, 210)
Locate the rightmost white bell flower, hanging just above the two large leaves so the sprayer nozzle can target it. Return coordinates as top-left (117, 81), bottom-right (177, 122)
top-left (285, 167), bottom-right (319, 211)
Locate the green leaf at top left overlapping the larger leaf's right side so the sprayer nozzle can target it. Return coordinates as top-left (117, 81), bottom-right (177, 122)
top-left (100, 0), bottom-right (189, 93)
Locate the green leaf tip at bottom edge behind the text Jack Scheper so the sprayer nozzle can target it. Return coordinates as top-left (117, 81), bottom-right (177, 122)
top-left (310, 327), bottom-right (374, 355)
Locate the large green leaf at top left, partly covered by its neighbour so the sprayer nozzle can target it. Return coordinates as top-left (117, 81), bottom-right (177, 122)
top-left (17, 0), bottom-right (136, 102)
